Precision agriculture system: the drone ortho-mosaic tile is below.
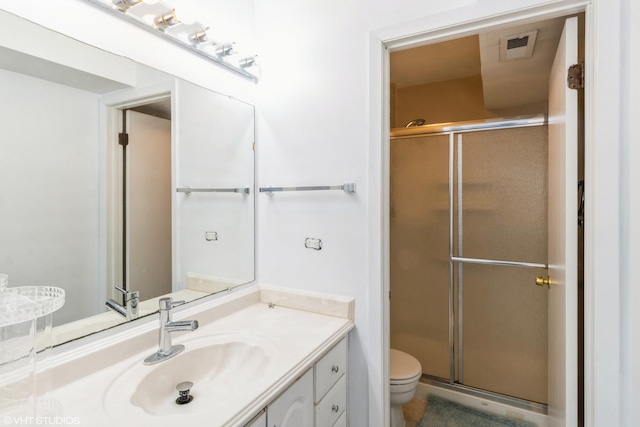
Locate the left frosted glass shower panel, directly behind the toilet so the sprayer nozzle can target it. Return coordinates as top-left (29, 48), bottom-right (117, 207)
top-left (390, 136), bottom-right (449, 378)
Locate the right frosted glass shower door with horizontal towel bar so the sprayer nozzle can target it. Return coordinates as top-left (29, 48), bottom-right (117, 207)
top-left (453, 126), bottom-right (547, 403)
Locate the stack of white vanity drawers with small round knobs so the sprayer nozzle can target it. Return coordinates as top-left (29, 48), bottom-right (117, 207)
top-left (314, 338), bottom-right (347, 427)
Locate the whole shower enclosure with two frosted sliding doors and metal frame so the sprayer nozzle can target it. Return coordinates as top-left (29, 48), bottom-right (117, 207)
top-left (390, 116), bottom-right (547, 412)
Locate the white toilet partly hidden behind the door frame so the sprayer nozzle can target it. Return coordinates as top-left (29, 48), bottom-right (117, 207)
top-left (389, 348), bottom-right (422, 427)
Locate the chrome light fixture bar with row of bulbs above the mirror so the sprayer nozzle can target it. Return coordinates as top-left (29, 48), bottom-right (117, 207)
top-left (87, 0), bottom-right (258, 82)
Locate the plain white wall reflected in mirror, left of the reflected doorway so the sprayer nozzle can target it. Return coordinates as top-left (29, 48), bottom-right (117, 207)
top-left (0, 70), bottom-right (103, 324)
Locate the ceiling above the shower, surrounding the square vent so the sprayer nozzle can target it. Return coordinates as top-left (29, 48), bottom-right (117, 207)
top-left (390, 17), bottom-right (566, 110)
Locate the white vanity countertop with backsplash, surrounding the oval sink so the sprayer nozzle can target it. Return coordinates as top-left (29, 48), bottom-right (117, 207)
top-left (51, 287), bottom-right (353, 427)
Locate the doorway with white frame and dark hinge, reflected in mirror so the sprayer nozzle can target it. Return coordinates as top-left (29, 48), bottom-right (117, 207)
top-left (107, 95), bottom-right (173, 306)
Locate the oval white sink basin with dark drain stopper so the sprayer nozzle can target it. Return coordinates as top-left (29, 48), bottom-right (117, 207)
top-left (104, 334), bottom-right (275, 418)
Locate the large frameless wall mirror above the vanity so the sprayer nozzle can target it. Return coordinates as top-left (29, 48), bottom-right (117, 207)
top-left (0, 11), bottom-right (255, 344)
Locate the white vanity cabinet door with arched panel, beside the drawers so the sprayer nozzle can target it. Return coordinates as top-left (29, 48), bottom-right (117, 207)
top-left (267, 369), bottom-right (313, 427)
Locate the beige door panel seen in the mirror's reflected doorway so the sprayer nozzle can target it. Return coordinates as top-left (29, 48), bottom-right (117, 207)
top-left (123, 106), bottom-right (172, 301)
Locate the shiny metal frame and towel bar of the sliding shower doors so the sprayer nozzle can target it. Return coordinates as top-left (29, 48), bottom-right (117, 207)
top-left (390, 114), bottom-right (548, 414)
